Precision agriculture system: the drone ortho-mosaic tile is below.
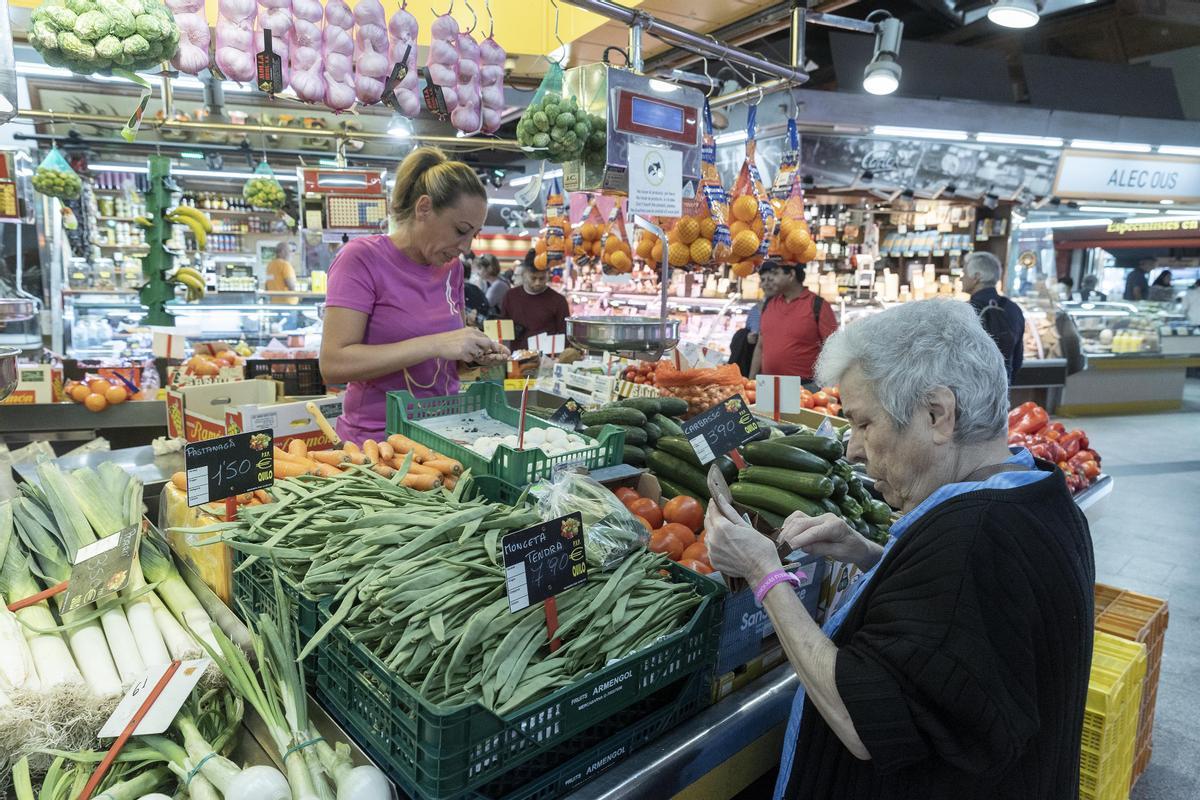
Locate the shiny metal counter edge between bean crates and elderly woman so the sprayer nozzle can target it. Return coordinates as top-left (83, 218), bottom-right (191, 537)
top-left (565, 663), bottom-right (799, 800)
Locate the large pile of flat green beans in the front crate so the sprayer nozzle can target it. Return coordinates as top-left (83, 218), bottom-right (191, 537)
top-left (187, 471), bottom-right (700, 714)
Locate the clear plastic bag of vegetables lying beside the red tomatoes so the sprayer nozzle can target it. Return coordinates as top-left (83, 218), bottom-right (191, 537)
top-left (529, 470), bottom-right (650, 570)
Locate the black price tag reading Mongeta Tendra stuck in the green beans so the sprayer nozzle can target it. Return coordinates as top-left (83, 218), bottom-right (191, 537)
top-left (500, 511), bottom-right (588, 614)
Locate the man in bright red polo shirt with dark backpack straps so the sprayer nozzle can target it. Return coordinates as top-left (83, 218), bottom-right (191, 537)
top-left (750, 259), bottom-right (838, 381)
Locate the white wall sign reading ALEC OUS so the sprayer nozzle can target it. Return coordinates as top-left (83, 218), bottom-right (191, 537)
top-left (1054, 150), bottom-right (1200, 203)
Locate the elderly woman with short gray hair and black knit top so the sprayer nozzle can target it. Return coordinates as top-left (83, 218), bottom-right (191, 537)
top-left (707, 300), bottom-right (1096, 800)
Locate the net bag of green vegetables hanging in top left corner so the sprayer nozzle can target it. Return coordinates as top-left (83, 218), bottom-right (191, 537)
top-left (29, 0), bottom-right (179, 74)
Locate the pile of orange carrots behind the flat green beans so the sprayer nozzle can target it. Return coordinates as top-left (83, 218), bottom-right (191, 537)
top-left (170, 433), bottom-right (462, 505)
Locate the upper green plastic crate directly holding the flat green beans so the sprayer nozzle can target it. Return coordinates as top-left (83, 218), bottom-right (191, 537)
top-left (316, 564), bottom-right (721, 800)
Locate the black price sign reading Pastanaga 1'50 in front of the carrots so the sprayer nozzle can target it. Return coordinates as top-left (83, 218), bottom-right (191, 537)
top-left (184, 431), bottom-right (275, 506)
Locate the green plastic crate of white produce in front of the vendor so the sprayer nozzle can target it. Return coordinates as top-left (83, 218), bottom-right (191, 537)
top-left (388, 383), bottom-right (625, 486)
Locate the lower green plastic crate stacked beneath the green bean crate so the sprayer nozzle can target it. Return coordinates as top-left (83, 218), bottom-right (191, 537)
top-left (325, 672), bottom-right (712, 800)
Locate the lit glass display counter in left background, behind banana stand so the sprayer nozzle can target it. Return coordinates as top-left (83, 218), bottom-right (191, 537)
top-left (62, 290), bottom-right (324, 359)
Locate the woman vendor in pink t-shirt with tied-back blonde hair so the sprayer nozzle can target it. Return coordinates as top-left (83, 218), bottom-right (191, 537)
top-left (320, 148), bottom-right (508, 443)
